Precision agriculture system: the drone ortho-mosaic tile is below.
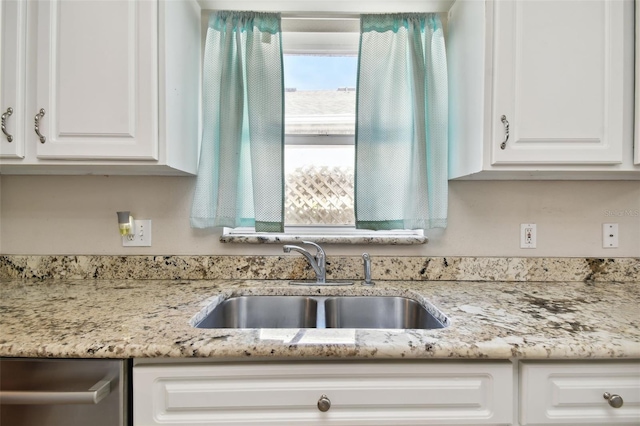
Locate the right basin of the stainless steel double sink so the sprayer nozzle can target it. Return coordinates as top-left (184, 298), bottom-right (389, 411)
top-left (324, 296), bottom-right (444, 329)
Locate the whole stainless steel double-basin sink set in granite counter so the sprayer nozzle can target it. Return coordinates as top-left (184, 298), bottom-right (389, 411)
top-left (192, 296), bottom-right (448, 329)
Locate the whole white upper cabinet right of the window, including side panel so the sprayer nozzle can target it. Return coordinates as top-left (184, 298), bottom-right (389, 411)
top-left (448, 0), bottom-right (640, 179)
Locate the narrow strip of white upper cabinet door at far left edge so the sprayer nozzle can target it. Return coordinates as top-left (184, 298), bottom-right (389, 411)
top-left (0, 0), bottom-right (27, 158)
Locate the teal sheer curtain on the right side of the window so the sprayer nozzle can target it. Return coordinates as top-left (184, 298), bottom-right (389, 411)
top-left (355, 14), bottom-right (448, 230)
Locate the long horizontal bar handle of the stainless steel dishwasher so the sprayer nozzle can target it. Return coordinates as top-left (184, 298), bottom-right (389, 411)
top-left (0, 376), bottom-right (112, 405)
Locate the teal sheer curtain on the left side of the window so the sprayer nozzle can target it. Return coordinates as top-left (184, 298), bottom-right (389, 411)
top-left (191, 11), bottom-right (284, 232)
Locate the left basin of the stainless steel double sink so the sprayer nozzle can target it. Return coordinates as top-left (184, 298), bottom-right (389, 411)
top-left (194, 296), bottom-right (318, 328)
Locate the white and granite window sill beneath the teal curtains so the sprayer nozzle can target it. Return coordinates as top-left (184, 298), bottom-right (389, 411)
top-left (220, 227), bottom-right (429, 245)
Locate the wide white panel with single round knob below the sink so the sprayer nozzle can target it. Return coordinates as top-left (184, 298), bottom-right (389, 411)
top-left (133, 362), bottom-right (513, 426)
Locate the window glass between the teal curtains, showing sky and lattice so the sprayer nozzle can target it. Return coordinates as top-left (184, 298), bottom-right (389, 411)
top-left (284, 55), bottom-right (357, 226)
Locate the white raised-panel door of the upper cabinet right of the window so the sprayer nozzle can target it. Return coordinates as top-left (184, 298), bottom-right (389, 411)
top-left (491, 0), bottom-right (628, 164)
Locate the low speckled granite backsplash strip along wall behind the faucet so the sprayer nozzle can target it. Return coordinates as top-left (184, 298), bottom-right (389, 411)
top-left (0, 255), bottom-right (640, 282)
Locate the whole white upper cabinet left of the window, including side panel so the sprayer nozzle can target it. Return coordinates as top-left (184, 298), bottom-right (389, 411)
top-left (0, 0), bottom-right (201, 174)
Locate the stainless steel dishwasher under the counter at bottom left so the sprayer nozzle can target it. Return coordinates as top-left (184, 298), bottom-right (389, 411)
top-left (0, 358), bottom-right (130, 426)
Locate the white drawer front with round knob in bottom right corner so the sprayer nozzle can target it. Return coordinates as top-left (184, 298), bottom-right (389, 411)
top-left (520, 361), bottom-right (640, 425)
